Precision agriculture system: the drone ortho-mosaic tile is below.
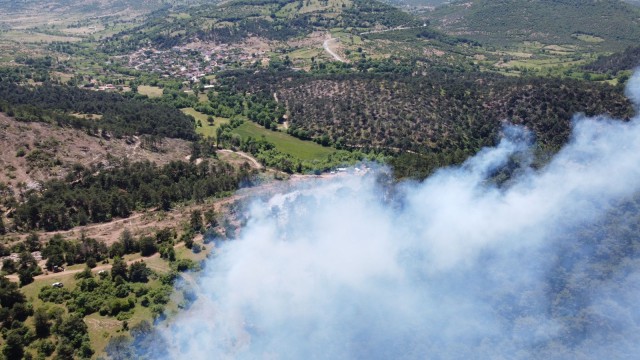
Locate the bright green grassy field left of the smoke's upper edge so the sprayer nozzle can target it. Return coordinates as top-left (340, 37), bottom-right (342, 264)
top-left (234, 121), bottom-right (336, 160)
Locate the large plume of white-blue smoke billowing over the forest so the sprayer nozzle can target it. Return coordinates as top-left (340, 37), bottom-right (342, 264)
top-left (158, 74), bottom-right (640, 360)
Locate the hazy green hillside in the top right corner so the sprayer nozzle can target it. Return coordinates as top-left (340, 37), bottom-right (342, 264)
top-left (429, 0), bottom-right (640, 50)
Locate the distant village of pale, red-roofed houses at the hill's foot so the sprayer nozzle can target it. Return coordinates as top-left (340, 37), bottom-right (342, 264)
top-left (129, 43), bottom-right (263, 81)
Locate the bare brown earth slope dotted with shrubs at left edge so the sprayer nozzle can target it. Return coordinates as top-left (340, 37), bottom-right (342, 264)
top-left (0, 113), bottom-right (190, 193)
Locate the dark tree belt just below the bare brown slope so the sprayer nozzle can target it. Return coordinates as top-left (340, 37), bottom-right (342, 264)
top-left (13, 161), bottom-right (251, 231)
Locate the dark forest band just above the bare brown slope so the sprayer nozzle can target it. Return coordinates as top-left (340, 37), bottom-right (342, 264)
top-left (0, 79), bottom-right (197, 140)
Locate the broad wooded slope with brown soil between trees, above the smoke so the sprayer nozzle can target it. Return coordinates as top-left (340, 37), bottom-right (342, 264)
top-left (224, 72), bottom-right (633, 154)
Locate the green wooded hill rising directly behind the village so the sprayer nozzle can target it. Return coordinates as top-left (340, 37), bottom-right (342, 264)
top-left (104, 0), bottom-right (417, 53)
